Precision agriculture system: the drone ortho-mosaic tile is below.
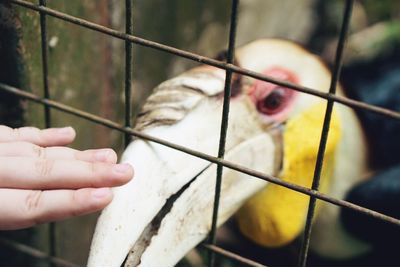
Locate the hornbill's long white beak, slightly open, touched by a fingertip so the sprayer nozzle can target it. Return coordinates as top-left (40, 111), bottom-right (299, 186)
top-left (88, 72), bottom-right (277, 267)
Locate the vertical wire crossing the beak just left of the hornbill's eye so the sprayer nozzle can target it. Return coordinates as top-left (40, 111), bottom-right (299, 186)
top-left (208, 0), bottom-right (239, 267)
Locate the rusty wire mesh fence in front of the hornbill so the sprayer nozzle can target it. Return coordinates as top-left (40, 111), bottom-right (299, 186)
top-left (0, 0), bottom-right (400, 266)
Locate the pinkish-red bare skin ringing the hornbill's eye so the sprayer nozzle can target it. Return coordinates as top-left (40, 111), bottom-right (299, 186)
top-left (249, 67), bottom-right (298, 123)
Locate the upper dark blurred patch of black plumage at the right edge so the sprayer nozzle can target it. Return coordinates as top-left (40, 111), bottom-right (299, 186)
top-left (343, 49), bottom-right (400, 169)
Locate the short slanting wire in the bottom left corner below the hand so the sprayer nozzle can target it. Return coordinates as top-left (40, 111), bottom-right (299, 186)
top-left (0, 237), bottom-right (79, 267)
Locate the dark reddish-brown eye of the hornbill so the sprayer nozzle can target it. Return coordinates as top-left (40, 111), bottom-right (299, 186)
top-left (257, 87), bottom-right (290, 115)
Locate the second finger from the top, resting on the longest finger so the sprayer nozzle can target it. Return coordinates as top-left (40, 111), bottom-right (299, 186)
top-left (0, 142), bottom-right (117, 163)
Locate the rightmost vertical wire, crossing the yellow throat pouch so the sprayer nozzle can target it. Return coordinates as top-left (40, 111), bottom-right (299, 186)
top-left (298, 0), bottom-right (354, 267)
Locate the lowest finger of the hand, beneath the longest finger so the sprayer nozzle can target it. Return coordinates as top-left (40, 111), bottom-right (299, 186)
top-left (0, 188), bottom-right (112, 230)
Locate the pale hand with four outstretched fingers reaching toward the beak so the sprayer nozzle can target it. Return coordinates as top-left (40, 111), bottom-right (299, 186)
top-left (0, 125), bottom-right (133, 230)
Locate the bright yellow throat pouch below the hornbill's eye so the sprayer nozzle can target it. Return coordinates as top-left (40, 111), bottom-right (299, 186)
top-left (237, 104), bottom-right (341, 247)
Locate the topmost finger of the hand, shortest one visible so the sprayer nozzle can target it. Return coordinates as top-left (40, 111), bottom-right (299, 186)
top-left (0, 125), bottom-right (76, 146)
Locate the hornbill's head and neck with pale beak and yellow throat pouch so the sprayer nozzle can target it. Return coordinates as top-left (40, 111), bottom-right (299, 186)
top-left (88, 39), bottom-right (371, 266)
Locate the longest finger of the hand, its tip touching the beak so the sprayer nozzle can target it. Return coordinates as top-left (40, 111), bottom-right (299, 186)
top-left (0, 157), bottom-right (133, 190)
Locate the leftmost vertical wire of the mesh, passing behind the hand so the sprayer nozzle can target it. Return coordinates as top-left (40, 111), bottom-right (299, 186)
top-left (39, 0), bottom-right (57, 266)
